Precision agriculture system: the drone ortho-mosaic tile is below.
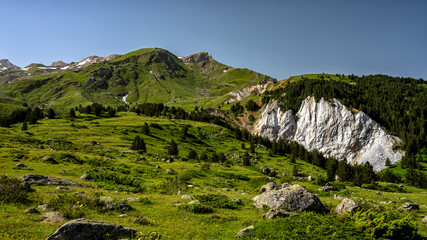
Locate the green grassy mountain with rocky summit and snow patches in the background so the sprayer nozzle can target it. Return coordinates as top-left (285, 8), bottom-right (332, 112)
top-left (1, 48), bottom-right (275, 108)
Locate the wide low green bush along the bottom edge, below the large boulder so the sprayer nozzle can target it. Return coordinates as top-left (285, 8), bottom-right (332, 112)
top-left (243, 211), bottom-right (421, 239)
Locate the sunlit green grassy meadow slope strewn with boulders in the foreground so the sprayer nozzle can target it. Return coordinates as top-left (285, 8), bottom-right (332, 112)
top-left (0, 112), bottom-right (427, 239)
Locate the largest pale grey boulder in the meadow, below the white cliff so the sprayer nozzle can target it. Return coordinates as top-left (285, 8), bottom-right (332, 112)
top-left (252, 185), bottom-right (326, 212)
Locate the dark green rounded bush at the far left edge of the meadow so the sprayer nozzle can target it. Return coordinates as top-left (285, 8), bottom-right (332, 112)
top-left (0, 176), bottom-right (31, 203)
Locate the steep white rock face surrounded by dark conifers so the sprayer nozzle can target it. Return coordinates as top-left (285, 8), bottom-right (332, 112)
top-left (252, 97), bottom-right (403, 171)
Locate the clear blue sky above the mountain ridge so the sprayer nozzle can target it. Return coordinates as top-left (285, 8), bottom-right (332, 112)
top-left (0, 0), bottom-right (427, 80)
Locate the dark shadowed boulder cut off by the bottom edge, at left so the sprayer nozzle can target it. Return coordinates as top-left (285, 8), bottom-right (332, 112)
top-left (46, 218), bottom-right (138, 240)
